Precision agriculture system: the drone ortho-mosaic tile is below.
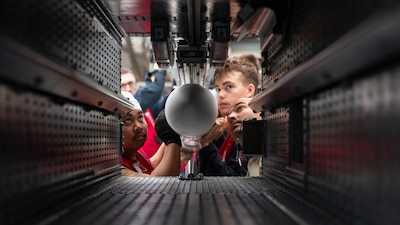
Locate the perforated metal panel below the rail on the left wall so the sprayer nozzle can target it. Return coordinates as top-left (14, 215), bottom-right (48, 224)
top-left (0, 84), bottom-right (121, 225)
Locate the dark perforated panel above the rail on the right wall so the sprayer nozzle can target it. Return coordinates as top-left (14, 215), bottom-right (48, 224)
top-left (263, 0), bottom-right (383, 88)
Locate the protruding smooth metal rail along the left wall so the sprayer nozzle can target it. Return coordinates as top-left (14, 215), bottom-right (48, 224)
top-left (0, 36), bottom-right (134, 114)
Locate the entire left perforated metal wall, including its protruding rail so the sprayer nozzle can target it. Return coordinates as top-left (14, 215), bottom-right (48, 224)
top-left (0, 0), bottom-right (122, 224)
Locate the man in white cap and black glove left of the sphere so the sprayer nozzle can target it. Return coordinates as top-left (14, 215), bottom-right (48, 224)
top-left (121, 92), bottom-right (181, 177)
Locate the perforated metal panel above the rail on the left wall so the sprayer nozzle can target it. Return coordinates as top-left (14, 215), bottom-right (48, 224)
top-left (0, 0), bottom-right (121, 93)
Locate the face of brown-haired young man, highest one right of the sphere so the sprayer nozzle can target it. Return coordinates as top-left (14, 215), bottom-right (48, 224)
top-left (215, 71), bottom-right (255, 116)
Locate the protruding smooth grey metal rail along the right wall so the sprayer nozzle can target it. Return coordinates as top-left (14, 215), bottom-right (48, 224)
top-left (249, 2), bottom-right (400, 111)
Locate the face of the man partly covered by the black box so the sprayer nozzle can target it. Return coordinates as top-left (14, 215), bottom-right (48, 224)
top-left (228, 98), bottom-right (261, 144)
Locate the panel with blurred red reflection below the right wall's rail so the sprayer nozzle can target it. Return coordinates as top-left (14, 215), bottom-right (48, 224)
top-left (308, 64), bottom-right (400, 223)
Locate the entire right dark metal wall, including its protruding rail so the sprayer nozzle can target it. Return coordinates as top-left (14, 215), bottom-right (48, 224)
top-left (254, 1), bottom-right (400, 224)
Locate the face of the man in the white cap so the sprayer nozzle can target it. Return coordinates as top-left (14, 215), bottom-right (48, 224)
top-left (122, 109), bottom-right (147, 152)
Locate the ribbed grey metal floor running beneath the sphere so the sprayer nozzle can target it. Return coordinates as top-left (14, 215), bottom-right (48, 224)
top-left (34, 177), bottom-right (337, 225)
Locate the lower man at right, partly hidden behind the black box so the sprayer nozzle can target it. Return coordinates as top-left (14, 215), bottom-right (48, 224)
top-left (228, 98), bottom-right (262, 176)
